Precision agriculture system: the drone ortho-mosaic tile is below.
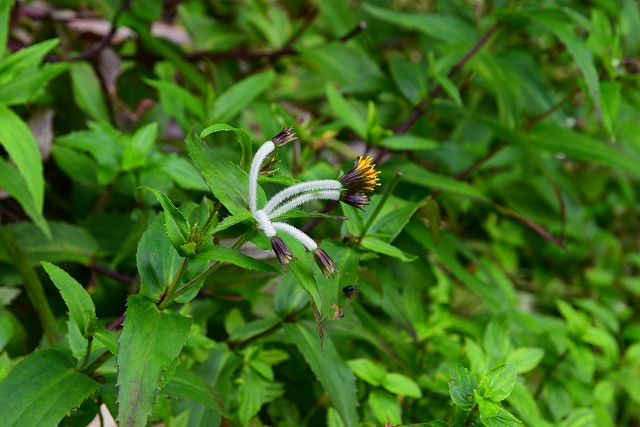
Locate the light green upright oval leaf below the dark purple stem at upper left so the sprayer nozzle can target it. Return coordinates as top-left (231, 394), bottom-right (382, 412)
top-left (69, 62), bottom-right (110, 122)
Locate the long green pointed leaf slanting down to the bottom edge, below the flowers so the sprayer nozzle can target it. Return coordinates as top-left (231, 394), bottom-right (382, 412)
top-left (284, 324), bottom-right (359, 427)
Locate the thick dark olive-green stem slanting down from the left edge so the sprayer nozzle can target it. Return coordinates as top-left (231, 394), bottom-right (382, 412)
top-left (0, 228), bottom-right (58, 344)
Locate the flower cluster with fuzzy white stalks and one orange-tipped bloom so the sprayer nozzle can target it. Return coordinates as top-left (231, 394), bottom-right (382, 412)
top-left (249, 128), bottom-right (380, 277)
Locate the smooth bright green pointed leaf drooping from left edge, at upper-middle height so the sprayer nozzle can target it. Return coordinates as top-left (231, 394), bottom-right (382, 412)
top-left (0, 103), bottom-right (44, 213)
